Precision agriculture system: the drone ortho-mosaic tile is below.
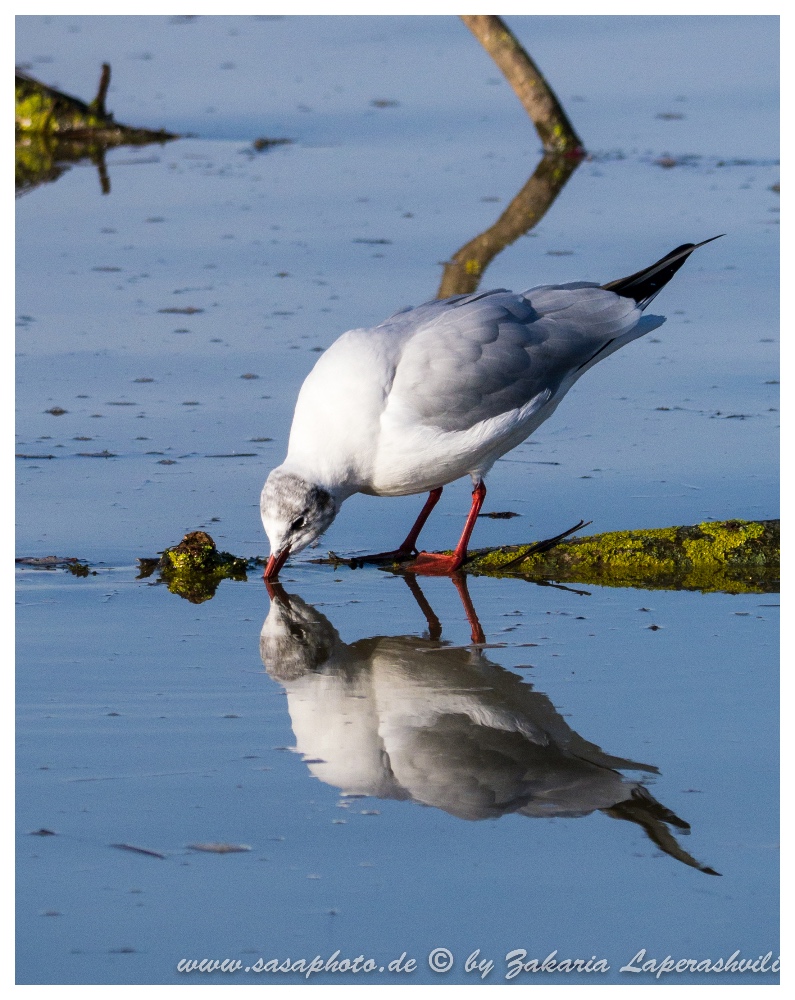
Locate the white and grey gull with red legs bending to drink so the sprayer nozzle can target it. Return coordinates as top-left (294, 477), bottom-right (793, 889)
top-left (260, 236), bottom-right (718, 580)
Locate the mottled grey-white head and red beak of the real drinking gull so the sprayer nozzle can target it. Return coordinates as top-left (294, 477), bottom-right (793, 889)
top-left (259, 466), bottom-right (338, 580)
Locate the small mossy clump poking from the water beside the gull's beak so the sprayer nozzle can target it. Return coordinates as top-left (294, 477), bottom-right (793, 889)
top-left (138, 531), bottom-right (248, 604)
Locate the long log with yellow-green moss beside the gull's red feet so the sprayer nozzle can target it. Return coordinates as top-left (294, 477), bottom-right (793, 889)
top-left (464, 520), bottom-right (780, 594)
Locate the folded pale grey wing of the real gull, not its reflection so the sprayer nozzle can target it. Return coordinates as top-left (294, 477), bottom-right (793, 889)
top-left (379, 283), bottom-right (646, 431)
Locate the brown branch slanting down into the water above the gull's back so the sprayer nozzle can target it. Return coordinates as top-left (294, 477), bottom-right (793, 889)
top-left (460, 14), bottom-right (584, 156)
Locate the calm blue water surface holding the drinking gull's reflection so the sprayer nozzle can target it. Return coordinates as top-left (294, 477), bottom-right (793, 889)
top-left (17, 16), bottom-right (779, 985)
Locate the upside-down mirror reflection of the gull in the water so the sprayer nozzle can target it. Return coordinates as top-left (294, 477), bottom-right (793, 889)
top-left (260, 574), bottom-right (718, 875)
